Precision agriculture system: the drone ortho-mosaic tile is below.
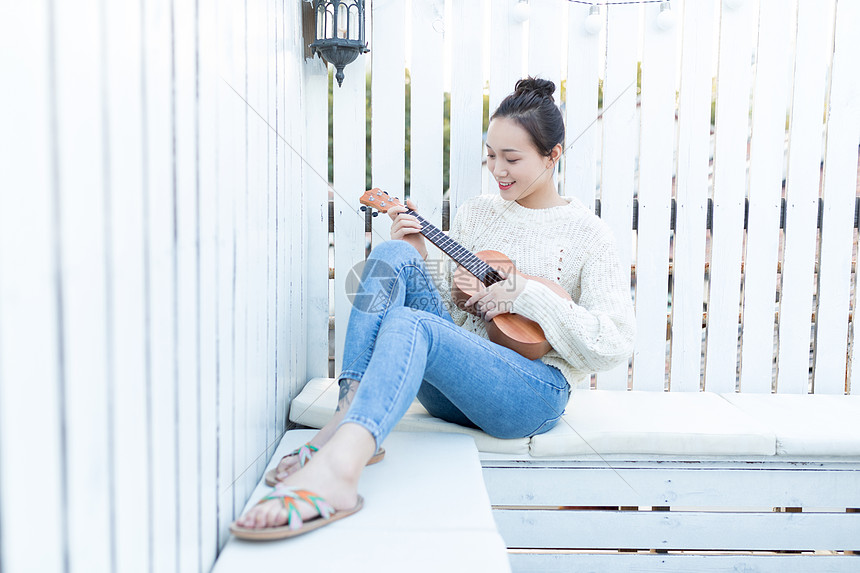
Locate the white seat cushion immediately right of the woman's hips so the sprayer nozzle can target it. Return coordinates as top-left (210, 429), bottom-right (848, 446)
top-left (531, 390), bottom-right (776, 457)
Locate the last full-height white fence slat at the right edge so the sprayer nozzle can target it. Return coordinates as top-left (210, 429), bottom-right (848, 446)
top-left (814, 2), bottom-right (860, 394)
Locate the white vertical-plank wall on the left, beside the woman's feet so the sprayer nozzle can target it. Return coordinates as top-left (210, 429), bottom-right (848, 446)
top-left (0, 0), bottom-right (318, 573)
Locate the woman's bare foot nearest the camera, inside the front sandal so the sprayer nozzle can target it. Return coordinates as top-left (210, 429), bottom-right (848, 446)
top-left (236, 424), bottom-right (376, 529)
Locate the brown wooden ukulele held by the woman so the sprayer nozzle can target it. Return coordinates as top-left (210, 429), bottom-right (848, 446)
top-left (359, 188), bottom-right (572, 360)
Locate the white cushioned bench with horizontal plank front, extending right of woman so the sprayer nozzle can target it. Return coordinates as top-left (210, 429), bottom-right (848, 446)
top-left (290, 378), bottom-right (860, 572)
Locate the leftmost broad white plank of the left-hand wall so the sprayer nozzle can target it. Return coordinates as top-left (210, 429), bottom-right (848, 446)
top-left (0, 1), bottom-right (68, 573)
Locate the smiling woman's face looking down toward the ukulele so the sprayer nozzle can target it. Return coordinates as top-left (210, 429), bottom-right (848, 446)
top-left (487, 117), bottom-right (558, 208)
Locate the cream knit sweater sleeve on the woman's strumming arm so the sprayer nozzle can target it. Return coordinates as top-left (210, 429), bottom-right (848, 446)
top-left (513, 231), bottom-right (636, 372)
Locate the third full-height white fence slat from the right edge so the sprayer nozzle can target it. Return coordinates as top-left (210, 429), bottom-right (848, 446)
top-left (740, 0), bottom-right (795, 393)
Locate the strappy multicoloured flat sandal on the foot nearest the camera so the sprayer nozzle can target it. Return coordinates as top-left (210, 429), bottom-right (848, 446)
top-left (230, 486), bottom-right (364, 541)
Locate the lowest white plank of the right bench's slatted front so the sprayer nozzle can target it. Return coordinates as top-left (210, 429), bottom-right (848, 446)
top-left (510, 552), bottom-right (857, 573)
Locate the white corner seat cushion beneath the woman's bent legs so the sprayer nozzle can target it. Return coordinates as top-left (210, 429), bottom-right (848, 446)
top-left (290, 378), bottom-right (529, 454)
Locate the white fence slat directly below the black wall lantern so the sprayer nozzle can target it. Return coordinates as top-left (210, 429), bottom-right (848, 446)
top-left (333, 60), bottom-right (366, 376)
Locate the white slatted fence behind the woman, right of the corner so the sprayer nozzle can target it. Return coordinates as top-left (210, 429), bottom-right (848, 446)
top-left (334, 0), bottom-right (860, 393)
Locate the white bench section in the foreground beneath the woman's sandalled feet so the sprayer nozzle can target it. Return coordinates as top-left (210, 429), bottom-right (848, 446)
top-left (213, 430), bottom-right (510, 573)
